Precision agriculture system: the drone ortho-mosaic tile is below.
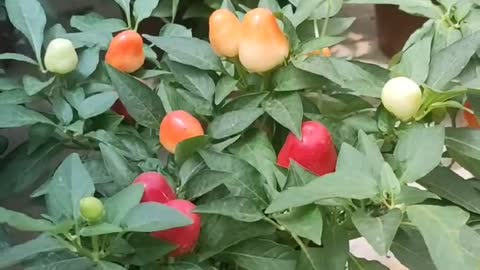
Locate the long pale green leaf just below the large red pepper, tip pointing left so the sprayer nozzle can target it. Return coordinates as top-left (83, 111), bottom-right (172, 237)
top-left (265, 173), bottom-right (378, 213)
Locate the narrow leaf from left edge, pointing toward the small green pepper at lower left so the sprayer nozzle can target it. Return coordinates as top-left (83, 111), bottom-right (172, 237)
top-left (0, 207), bottom-right (55, 232)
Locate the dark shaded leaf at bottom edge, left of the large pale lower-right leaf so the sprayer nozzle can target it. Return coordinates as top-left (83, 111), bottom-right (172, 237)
top-left (391, 227), bottom-right (437, 270)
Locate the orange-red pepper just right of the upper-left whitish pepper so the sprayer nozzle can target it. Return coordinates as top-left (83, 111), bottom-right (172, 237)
top-left (105, 30), bottom-right (145, 73)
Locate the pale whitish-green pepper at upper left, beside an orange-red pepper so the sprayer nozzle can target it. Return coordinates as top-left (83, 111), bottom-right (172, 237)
top-left (44, 38), bottom-right (78, 74)
